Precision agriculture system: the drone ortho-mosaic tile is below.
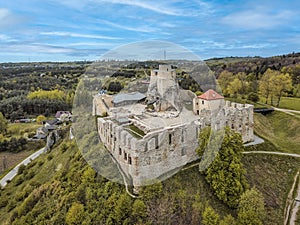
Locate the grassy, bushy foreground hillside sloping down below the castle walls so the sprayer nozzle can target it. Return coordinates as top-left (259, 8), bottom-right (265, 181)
top-left (0, 124), bottom-right (300, 225)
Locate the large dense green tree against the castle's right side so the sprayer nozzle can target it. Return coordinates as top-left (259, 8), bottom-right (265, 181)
top-left (198, 127), bottom-right (248, 208)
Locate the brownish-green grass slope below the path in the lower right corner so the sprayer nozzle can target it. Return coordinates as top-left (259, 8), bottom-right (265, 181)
top-left (242, 154), bottom-right (300, 225)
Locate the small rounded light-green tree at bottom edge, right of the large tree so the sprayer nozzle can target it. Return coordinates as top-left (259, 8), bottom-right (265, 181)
top-left (238, 188), bottom-right (266, 225)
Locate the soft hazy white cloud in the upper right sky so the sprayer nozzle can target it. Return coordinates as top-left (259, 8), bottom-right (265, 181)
top-left (222, 9), bottom-right (294, 29)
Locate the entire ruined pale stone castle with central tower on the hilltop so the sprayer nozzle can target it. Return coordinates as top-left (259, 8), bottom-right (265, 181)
top-left (93, 65), bottom-right (253, 191)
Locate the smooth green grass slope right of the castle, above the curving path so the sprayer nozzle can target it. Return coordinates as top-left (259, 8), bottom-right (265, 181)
top-left (254, 111), bottom-right (300, 154)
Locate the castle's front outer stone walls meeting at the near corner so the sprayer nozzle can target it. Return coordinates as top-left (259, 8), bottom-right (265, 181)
top-left (98, 118), bottom-right (199, 187)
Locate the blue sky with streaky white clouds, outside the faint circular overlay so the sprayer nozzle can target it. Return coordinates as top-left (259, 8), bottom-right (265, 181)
top-left (0, 0), bottom-right (300, 62)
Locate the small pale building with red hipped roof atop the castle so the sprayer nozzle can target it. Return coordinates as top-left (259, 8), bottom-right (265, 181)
top-left (193, 89), bottom-right (224, 115)
